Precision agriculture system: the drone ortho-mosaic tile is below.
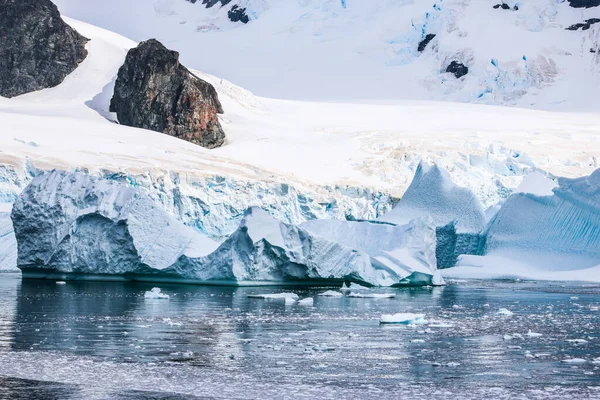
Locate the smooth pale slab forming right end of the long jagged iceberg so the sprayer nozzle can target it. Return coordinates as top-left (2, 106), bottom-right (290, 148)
top-left (300, 219), bottom-right (443, 284)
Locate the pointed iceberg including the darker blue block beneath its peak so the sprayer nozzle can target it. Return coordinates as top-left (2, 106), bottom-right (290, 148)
top-left (378, 162), bottom-right (486, 268)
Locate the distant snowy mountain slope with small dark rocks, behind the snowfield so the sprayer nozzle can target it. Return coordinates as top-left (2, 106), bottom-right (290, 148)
top-left (55, 0), bottom-right (600, 111)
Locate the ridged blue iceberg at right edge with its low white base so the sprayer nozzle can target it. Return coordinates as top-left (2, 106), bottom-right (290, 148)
top-left (444, 170), bottom-right (600, 281)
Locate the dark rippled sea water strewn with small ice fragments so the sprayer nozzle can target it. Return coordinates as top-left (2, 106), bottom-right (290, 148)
top-left (0, 274), bottom-right (600, 400)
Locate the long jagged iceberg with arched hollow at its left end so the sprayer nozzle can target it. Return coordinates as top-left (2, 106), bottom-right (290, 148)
top-left (12, 171), bottom-right (441, 286)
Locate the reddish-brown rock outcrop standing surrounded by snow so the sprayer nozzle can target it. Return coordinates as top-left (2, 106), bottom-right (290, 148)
top-left (110, 39), bottom-right (225, 148)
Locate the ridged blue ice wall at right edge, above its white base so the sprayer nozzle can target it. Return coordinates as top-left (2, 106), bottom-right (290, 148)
top-left (485, 170), bottom-right (600, 271)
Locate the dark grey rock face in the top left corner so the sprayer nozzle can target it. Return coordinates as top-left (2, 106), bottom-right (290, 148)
top-left (0, 0), bottom-right (88, 97)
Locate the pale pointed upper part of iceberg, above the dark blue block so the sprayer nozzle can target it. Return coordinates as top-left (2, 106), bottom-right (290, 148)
top-left (378, 162), bottom-right (486, 233)
